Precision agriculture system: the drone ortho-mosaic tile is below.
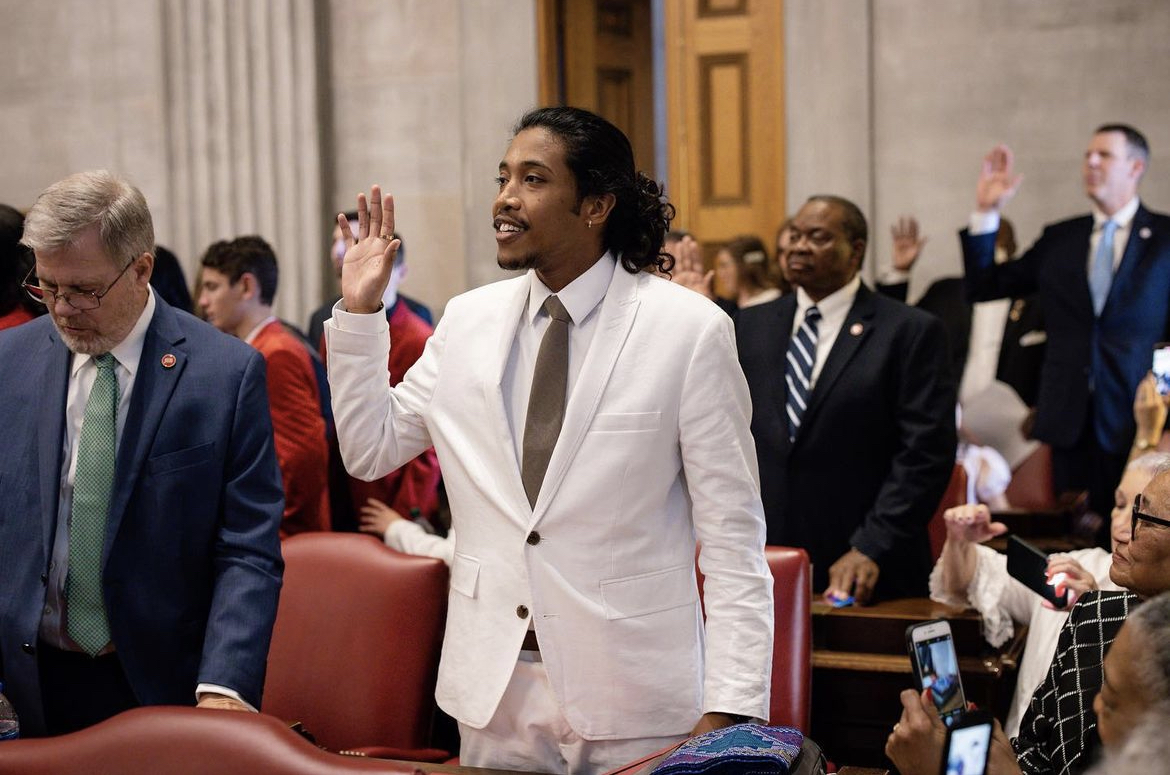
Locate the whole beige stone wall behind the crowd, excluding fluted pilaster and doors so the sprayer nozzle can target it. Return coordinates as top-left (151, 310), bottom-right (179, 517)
top-left (0, 0), bottom-right (1170, 322)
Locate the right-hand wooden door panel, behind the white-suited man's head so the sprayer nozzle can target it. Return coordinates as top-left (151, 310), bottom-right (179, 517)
top-left (663, 0), bottom-right (785, 260)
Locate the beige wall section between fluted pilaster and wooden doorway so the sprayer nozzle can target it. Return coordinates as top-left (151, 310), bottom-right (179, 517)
top-left (326, 0), bottom-right (536, 313)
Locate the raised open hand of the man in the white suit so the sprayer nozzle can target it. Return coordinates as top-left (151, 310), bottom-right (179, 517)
top-left (337, 185), bottom-right (401, 313)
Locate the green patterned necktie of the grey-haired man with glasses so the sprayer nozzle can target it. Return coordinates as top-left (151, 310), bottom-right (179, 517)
top-left (66, 352), bottom-right (118, 657)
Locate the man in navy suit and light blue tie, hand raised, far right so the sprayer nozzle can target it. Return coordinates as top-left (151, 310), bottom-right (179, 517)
top-left (961, 124), bottom-right (1170, 529)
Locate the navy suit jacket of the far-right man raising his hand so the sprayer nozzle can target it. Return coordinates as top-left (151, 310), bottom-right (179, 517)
top-left (959, 207), bottom-right (1170, 454)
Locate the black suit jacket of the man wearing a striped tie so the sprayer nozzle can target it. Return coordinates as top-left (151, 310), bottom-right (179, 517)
top-left (736, 286), bottom-right (956, 598)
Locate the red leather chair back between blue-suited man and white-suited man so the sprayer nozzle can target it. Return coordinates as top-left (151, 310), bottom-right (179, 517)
top-left (263, 533), bottom-right (447, 750)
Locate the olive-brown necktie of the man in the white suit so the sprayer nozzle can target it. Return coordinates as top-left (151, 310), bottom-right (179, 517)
top-left (521, 296), bottom-right (573, 507)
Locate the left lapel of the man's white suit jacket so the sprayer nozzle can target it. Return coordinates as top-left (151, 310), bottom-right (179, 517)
top-left (483, 276), bottom-right (531, 514)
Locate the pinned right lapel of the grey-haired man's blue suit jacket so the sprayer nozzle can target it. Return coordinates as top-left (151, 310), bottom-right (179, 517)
top-left (105, 295), bottom-right (187, 556)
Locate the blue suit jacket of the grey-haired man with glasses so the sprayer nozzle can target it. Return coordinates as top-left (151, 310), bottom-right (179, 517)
top-left (0, 296), bottom-right (284, 735)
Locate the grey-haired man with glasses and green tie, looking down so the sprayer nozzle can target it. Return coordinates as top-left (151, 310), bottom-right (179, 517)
top-left (0, 171), bottom-right (283, 735)
